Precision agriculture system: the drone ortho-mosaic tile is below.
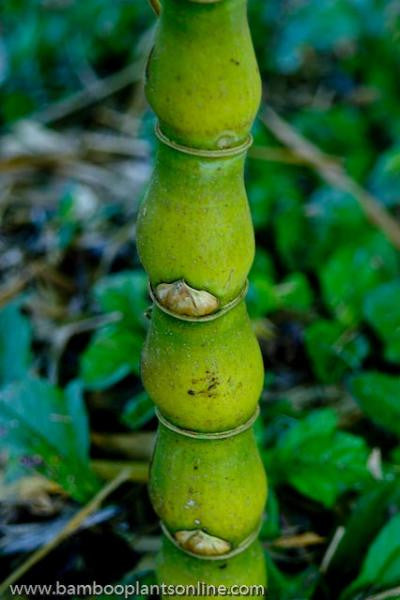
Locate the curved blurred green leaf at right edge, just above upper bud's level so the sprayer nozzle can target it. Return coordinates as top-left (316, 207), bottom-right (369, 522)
top-left (320, 233), bottom-right (398, 325)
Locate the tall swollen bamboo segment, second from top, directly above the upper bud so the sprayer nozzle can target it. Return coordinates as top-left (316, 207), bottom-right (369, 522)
top-left (137, 144), bottom-right (254, 316)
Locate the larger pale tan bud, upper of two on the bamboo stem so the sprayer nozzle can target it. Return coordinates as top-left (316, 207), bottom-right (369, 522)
top-left (155, 279), bottom-right (219, 317)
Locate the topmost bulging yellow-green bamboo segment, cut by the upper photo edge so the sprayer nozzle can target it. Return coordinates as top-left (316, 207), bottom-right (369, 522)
top-left (146, 0), bottom-right (261, 149)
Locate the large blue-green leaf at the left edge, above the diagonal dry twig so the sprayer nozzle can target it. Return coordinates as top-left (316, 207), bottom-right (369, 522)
top-left (0, 377), bottom-right (98, 502)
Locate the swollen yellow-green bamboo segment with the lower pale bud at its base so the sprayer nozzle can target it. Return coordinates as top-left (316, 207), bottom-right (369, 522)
top-left (150, 424), bottom-right (266, 555)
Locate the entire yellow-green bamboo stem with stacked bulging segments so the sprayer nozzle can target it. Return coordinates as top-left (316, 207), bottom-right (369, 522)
top-left (137, 0), bottom-right (267, 585)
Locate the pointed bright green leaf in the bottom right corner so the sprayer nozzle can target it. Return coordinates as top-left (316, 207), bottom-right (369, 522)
top-left (341, 514), bottom-right (400, 600)
